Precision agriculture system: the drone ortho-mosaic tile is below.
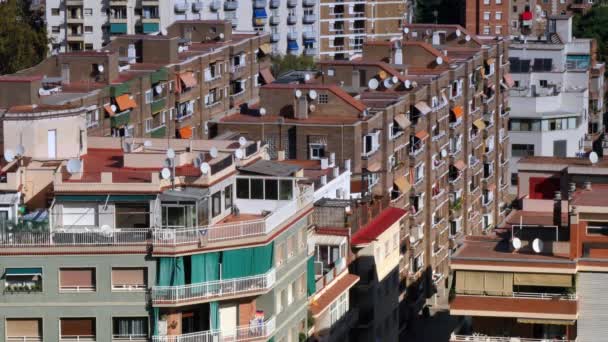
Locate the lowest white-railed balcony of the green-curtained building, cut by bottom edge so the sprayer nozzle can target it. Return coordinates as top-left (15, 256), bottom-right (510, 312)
top-left (152, 316), bottom-right (276, 342)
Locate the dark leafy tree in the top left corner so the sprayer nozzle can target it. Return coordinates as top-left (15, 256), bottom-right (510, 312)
top-left (0, 0), bottom-right (48, 75)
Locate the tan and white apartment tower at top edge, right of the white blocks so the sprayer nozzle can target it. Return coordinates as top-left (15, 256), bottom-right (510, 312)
top-left (318, 0), bottom-right (413, 60)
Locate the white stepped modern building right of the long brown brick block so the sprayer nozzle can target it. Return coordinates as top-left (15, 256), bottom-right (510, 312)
top-left (509, 16), bottom-right (605, 193)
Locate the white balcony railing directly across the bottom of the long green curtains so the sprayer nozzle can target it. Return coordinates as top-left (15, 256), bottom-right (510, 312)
top-left (152, 268), bottom-right (276, 305)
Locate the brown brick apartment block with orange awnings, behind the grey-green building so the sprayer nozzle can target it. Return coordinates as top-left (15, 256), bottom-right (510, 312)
top-left (0, 21), bottom-right (273, 139)
